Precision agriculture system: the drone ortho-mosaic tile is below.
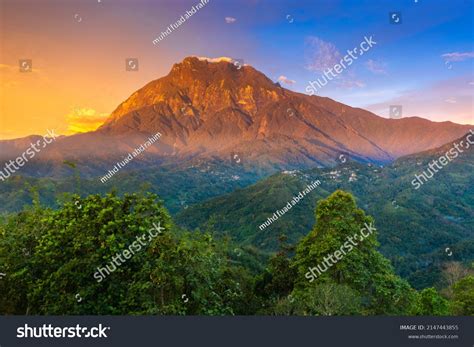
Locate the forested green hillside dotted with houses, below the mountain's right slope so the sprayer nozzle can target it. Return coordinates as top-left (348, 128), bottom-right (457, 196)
top-left (175, 132), bottom-right (474, 288)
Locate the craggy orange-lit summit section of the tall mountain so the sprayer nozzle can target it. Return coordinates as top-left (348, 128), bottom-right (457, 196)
top-left (103, 56), bottom-right (285, 127)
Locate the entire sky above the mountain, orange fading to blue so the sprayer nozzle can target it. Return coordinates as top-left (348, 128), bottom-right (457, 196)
top-left (0, 0), bottom-right (474, 139)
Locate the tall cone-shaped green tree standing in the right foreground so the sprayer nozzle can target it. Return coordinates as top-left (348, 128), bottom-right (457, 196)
top-left (293, 191), bottom-right (416, 315)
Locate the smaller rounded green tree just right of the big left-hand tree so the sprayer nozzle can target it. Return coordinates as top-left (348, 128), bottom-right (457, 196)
top-left (150, 230), bottom-right (243, 315)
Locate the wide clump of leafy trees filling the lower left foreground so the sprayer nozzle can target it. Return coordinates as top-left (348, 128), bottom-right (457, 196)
top-left (0, 194), bottom-right (252, 315)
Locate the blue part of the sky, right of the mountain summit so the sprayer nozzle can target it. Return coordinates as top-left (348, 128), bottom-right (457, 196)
top-left (208, 0), bottom-right (474, 124)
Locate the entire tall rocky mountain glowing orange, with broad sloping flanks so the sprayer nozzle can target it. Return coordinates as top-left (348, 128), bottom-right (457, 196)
top-left (0, 57), bottom-right (469, 175)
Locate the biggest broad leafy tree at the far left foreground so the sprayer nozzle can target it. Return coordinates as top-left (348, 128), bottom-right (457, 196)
top-left (0, 194), bottom-right (171, 314)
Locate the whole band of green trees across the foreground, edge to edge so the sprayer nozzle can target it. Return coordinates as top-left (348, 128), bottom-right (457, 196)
top-left (0, 189), bottom-right (474, 315)
